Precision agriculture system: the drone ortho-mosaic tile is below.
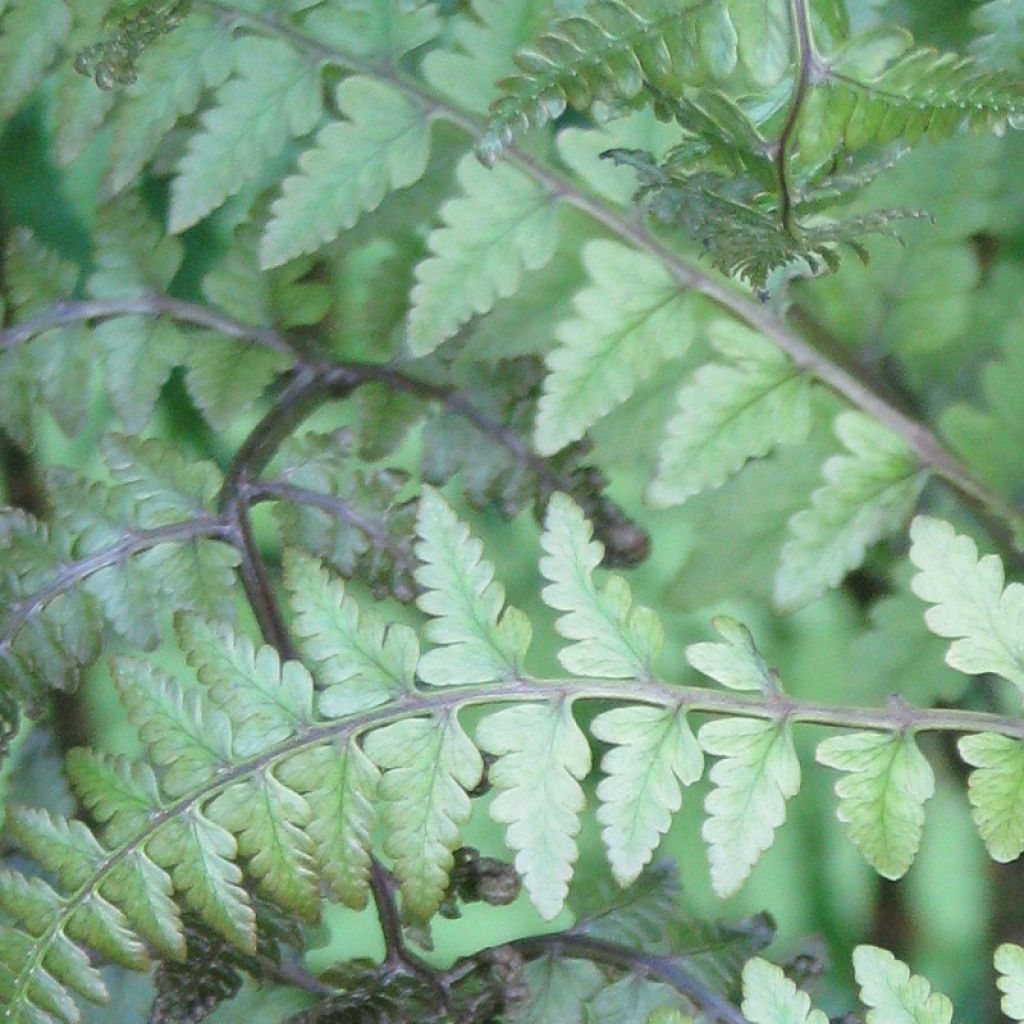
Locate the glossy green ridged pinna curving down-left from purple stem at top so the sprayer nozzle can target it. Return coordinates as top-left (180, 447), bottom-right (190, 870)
top-left (477, 0), bottom-right (736, 164)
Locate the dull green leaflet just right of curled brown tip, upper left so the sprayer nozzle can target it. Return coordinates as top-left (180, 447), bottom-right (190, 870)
top-left (105, 11), bottom-right (236, 195)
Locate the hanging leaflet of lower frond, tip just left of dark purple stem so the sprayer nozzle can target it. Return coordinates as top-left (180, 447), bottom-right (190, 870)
top-left (279, 738), bottom-right (380, 910)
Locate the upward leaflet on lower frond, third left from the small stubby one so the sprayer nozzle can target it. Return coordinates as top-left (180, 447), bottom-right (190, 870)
top-left (285, 548), bottom-right (420, 718)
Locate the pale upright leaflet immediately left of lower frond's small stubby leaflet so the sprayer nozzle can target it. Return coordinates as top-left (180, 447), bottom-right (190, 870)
top-left (541, 494), bottom-right (665, 679)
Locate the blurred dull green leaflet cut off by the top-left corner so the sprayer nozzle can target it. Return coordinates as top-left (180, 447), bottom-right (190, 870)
top-left (0, 0), bottom-right (71, 121)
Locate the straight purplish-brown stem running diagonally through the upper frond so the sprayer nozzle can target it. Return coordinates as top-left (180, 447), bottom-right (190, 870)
top-left (192, 0), bottom-right (1024, 544)
